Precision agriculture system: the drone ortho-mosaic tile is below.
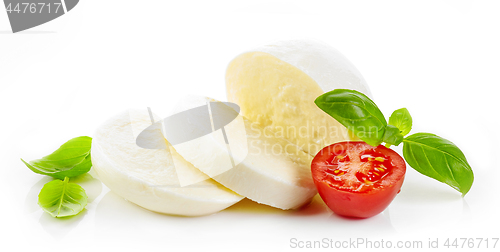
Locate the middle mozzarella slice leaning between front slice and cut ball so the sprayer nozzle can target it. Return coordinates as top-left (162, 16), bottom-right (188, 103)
top-left (167, 97), bottom-right (317, 209)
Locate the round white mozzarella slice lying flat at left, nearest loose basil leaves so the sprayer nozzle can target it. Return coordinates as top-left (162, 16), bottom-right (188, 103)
top-left (91, 109), bottom-right (243, 216)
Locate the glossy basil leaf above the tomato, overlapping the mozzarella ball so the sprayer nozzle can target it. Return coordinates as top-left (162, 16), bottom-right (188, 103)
top-left (314, 89), bottom-right (387, 146)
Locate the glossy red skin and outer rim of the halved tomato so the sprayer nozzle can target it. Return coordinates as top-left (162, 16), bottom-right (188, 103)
top-left (311, 142), bottom-right (406, 218)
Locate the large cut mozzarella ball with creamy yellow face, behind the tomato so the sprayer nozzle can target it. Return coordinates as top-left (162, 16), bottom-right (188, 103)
top-left (226, 40), bottom-right (370, 155)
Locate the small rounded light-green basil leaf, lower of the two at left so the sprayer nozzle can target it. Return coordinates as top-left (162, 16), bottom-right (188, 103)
top-left (38, 177), bottom-right (88, 217)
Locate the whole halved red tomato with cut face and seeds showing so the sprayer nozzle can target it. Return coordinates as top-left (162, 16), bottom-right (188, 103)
top-left (311, 142), bottom-right (406, 218)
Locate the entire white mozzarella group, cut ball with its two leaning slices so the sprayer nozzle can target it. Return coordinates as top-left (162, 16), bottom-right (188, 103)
top-left (92, 41), bottom-right (369, 216)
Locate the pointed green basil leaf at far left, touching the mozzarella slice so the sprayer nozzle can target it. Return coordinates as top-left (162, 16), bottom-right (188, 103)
top-left (21, 136), bottom-right (92, 179)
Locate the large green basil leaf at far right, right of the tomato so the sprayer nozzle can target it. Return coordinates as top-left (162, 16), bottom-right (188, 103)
top-left (403, 133), bottom-right (474, 196)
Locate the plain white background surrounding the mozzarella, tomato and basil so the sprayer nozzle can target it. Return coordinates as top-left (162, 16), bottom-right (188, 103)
top-left (0, 0), bottom-right (500, 251)
